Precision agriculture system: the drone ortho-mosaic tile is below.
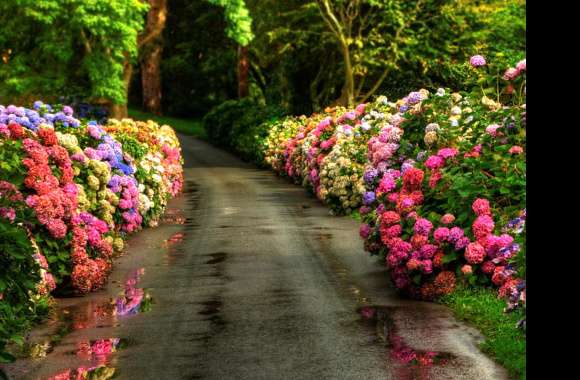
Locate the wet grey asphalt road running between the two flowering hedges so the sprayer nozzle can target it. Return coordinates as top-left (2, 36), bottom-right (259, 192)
top-left (6, 137), bottom-right (506, 380)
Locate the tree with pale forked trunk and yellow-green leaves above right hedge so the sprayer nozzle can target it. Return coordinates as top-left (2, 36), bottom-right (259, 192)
top-left (315, 0), bottom-right (524, 106)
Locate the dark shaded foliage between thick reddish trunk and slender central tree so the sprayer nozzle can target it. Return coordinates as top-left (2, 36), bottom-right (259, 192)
top-left (154, 0), bottom-right (237, 116)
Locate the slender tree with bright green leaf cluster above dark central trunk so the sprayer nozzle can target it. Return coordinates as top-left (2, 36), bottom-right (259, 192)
top-left (208, 0), bottom-right (254, 98)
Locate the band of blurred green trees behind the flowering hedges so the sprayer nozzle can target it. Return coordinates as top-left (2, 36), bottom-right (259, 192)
top-left (0, 0), bottom-right (526, 117)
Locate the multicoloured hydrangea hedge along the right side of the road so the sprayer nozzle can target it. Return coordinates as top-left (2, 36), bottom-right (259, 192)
top-left (215, 56), bottom-right (526, 318)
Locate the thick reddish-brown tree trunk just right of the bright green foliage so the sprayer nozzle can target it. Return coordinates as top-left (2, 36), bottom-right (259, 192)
top-left (140, 0), bottom-right (167, 115)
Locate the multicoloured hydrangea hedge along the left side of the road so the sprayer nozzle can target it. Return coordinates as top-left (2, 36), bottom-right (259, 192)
top-left (0, 102), bottom-right (183, 359)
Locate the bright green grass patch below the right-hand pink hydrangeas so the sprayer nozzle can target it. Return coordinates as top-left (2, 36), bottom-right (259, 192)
top-left (440, 286), bottom-right (526, 379)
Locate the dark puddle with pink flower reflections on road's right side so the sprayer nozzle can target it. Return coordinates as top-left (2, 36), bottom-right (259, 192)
top-left (358, 306), bottom-right (454, 367)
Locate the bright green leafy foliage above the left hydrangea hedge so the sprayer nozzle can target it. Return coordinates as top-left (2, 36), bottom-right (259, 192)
top-left (0, 0), bottom-right (148, 104)
